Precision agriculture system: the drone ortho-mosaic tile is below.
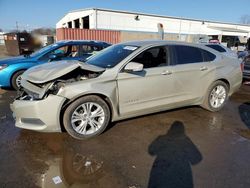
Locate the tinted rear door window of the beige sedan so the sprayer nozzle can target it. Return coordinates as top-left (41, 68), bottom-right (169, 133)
top-left (175, 45), bottom-right (203, 65)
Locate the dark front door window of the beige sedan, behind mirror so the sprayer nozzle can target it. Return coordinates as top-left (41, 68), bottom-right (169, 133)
top-left (132, 46), bottom-right (169, 68)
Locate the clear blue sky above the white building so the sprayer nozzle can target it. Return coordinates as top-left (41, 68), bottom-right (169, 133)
top-left (0, 0), bottom-right (250, 30)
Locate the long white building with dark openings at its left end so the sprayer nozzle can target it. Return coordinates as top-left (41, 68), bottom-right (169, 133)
top-left (56, 8), bottom-right (250, 42)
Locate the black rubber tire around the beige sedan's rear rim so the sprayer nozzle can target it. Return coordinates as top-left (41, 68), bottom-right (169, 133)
top-left (201, 80), bottom-right (229, 112)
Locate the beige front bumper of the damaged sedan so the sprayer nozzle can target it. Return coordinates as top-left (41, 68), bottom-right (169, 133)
top-left (10, 95), bottom-right (65, 132)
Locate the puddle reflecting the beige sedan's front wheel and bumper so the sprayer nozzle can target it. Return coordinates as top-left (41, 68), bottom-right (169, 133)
top-left (36, 148), bottom-right (124, 188)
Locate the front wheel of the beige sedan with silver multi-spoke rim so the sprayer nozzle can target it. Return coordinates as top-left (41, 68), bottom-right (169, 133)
top-left (63, 95), bottom-right (110, 140)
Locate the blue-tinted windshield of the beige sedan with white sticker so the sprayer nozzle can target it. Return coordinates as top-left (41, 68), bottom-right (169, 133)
top-left (86, 44), bottom-right (138, 68)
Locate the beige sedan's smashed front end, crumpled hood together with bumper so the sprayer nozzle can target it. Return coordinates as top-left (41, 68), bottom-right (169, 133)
top-left (11, 61), bottom-right (104, 132)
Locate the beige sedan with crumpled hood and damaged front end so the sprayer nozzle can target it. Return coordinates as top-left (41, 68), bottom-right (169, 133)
top-left (11, 41), bottom-right (242, 139)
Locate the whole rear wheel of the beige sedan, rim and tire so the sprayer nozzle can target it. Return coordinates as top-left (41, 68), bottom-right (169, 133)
top-left (202, 80), bottom-right (229, 112)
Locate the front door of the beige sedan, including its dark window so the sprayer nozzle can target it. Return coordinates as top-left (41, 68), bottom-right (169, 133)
top-left (117, 46), bottom-right (175, 115)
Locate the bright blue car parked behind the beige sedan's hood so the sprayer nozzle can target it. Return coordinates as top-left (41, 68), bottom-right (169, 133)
top-left (0, 40), bottom-right (110, 90)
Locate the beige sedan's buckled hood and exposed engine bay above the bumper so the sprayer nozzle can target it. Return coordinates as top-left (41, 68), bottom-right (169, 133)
top-left (17, 61), bottom-right (105, 100)
